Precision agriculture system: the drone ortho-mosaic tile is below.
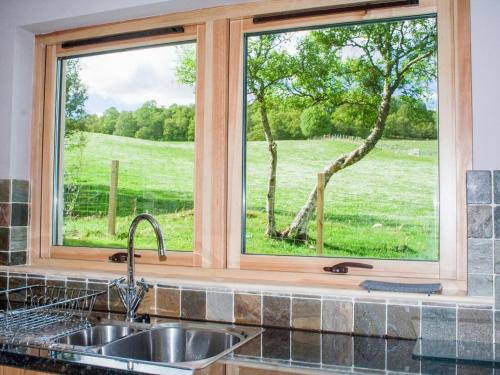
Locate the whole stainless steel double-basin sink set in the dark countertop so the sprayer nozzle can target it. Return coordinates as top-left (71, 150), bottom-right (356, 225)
top-left (55, 321), bottom-right (262, 369)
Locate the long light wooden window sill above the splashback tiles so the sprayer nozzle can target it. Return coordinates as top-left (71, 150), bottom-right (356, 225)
top-left (0, 259), bottom-right (495, 308)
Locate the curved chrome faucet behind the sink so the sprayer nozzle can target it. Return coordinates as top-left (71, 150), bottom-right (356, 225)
top-left (118, 214), bottom-right (167, 322)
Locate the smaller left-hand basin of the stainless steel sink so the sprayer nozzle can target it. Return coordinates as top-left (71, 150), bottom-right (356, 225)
top-left (56, 325), bottom-right (136, 346)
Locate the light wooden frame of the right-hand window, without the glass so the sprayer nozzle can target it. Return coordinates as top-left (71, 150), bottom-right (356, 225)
top-left (228, 0), bottom-right (472, 290)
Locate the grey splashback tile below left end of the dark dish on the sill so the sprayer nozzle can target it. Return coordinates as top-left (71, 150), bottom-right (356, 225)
top-left (354, 303), bottom-right (386, 336)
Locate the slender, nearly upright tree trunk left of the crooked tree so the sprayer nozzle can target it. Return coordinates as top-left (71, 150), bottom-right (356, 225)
top-left (257, 96), bottom-right (278, 238)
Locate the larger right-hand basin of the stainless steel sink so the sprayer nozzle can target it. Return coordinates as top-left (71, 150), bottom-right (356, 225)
top-left (99, 323), bottom-right (246, 368)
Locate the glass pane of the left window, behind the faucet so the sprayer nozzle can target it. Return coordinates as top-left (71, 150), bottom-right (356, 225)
top-left (53, 42), bottom-right (196, 251)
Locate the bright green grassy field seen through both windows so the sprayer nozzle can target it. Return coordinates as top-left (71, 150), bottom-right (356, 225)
top-left (64, 133), bottom-right (438, 260)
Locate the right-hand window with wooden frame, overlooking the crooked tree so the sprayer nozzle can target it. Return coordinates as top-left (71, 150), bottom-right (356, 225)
top-left (228, 1), bottom-right (471, 289)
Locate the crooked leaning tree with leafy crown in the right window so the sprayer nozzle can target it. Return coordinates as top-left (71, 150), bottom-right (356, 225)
top-left (282, 18), bottom-right (436, 240)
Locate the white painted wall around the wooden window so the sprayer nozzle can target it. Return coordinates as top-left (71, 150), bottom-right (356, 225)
top-left (0, 0), bottom-right (500, 178)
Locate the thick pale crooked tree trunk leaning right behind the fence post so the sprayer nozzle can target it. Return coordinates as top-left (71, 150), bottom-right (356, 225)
top-left (282, 83), bottom-right (393, 240)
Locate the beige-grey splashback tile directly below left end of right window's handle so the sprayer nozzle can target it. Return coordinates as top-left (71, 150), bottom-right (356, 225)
top-left (322, 299), bottom-right (353, 333)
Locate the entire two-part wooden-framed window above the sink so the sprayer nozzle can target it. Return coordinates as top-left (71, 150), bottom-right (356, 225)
top-left (31, 0), bottom-right (471, 291)
